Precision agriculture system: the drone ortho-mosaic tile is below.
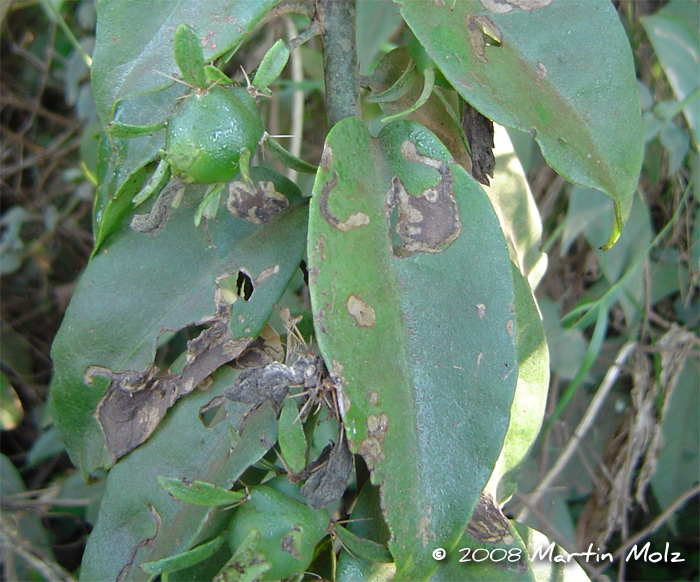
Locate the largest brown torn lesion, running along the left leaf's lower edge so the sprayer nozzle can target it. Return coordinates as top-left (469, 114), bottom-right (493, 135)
top-left (83, 289), bottom-right (253, 463)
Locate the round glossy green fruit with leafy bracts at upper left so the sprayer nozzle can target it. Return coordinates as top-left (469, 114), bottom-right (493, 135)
top-left (164, 85), bottom-right (265, 184)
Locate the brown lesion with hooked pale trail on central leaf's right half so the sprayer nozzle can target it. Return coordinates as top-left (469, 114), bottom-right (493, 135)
top-left (386, 140), bottom-right (462, 257)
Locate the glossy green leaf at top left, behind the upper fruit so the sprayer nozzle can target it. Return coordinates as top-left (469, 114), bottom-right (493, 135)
top-left (92, 0), bottom-right (280, 125)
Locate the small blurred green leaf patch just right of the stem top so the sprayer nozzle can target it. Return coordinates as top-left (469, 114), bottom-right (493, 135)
top-left (355, 0), bottom-right (403, 75)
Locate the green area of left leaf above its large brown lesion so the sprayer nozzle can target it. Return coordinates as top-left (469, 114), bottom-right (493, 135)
top-left (51, 169), bottom-right (307, 475)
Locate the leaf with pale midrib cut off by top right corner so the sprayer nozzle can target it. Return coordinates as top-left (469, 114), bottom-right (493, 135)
top-left (641, 0), bottom-right (700, 145)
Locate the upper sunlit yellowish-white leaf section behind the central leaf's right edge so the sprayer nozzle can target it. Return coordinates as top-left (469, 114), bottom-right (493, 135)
top-left (483, 125), bottom-right (547, 290)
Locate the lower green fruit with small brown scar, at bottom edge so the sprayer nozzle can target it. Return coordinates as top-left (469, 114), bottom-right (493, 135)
top-left (228, 485), bottom-right (330, 580)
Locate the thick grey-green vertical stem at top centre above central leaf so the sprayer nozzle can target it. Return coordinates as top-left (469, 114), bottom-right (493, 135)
top-left (316, 0), bottom-right (360, 127)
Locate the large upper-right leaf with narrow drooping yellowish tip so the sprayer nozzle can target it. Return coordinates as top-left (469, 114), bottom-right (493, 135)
top-left (397, 0), bottom-right (644, 245)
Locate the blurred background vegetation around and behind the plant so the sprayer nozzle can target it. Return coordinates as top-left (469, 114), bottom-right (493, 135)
top-left (0, 0), bottom-right (700, 580)
